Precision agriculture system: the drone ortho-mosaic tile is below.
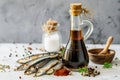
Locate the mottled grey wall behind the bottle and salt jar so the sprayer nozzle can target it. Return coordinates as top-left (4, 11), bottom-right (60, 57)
top-left (0, 0), bottom-right (120, 44)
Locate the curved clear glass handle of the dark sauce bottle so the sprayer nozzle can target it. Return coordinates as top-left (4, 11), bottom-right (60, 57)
top-left (82, 20), bottom-right (93, 40)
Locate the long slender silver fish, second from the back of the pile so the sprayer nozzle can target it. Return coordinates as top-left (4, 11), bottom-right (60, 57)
top-left (17, 54), bottom-right (58, 71)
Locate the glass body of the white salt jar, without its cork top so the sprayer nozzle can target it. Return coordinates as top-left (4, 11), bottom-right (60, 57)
top-left (43, 31), bottom-right (61, 52)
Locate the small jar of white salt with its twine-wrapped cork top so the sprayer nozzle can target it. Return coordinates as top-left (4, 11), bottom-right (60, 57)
top-left (43, 19), bottom-right (61, 52)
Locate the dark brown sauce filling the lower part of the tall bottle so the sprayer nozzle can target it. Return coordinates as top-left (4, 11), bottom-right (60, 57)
top-left (62, 30), bottom-right (89, 69)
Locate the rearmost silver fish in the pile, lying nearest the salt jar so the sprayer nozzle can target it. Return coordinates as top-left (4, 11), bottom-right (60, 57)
top-left (17, 53), bottom-right (53, 64)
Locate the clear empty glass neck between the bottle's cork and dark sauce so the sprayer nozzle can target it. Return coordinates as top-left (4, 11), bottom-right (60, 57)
top-left (71, 15), bottom-right (82, 30)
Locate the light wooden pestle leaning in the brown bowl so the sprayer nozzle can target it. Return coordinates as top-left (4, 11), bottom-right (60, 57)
top-left (98, 36), bottom-right (113, 55)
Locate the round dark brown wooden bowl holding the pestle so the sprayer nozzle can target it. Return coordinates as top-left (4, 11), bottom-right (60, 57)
top-left (88, 48), bottom-right (115, 64)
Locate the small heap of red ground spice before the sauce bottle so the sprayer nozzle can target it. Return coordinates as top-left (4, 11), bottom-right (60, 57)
top-left (54, 68), bottom-right (71, 76)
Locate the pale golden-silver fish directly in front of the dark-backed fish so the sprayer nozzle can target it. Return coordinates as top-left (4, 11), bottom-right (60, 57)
top-left (34, 59), bottom-right (59, 77)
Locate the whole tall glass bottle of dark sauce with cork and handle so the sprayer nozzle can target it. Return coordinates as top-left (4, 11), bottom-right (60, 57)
top-left (62, 3), bottom-right (93, 70)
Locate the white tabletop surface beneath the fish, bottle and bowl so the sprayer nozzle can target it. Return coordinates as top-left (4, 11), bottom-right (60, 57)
top-left (0, 43), bottom-right (120, 80)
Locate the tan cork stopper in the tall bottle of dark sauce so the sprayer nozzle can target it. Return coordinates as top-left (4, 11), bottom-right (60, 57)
top-left (70, 3), bottom-right (82, 16)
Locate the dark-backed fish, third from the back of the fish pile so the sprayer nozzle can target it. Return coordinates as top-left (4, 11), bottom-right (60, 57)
top-left (24, 58), bottom-right (52, 75)
